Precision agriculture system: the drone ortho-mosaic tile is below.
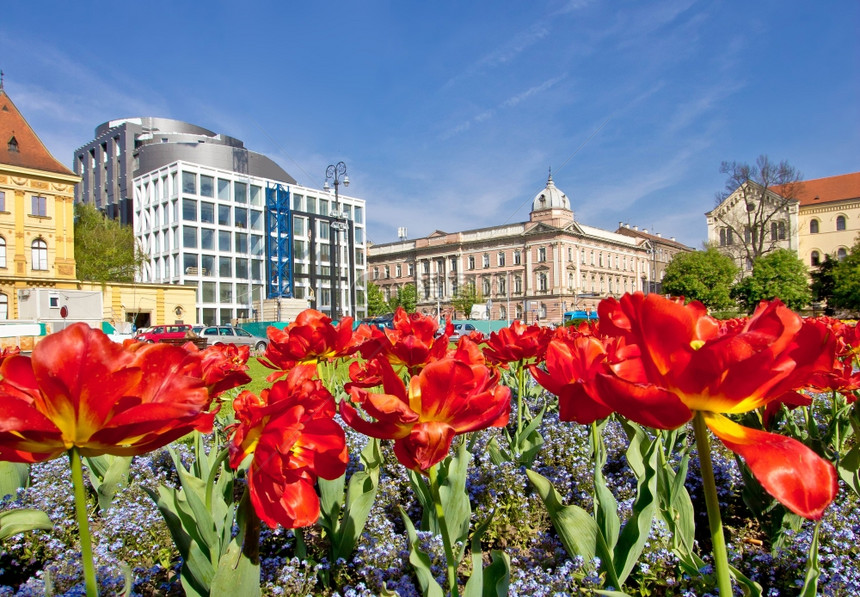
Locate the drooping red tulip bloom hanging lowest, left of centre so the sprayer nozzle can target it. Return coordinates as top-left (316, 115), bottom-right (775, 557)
top-left (230, 365), bottom-right (348, 528)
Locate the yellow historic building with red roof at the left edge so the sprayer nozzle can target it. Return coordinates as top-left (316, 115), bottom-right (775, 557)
top-left (0, 80), bottom-right (196, 336)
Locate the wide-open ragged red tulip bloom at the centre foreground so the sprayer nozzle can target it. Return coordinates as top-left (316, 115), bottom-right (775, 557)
top-left (340, 350), bottom-right (511, 471)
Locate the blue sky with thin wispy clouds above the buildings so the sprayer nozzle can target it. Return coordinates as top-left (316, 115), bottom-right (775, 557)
top-left (0, 0), bottom-right (860, 247)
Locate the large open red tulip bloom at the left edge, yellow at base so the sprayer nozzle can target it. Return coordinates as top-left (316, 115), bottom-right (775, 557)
top-left (0, 323), bottom-right (217, 462)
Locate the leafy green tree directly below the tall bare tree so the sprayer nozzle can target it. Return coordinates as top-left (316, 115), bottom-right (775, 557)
top-left (732, 249), bottom-right (812, 313)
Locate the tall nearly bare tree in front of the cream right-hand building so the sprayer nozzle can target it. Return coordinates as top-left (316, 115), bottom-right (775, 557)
top-left (709, 155), bottom-right (801, 264)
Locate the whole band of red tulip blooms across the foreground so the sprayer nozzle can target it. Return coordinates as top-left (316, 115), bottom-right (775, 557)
top-left (0, 293), bottom-right (860, 594)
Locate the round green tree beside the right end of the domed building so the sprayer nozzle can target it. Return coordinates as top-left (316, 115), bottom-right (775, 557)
top-left (663, 247), bottom-right (738, 310)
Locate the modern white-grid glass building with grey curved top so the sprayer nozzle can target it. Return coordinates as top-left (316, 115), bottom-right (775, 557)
top-left (75, 117), bottom-right (366, 324)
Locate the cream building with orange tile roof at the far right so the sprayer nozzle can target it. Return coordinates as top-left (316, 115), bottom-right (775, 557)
top-left (705, 172), bottom-right (860, 271)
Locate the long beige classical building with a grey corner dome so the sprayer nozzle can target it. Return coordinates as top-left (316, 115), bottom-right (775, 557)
top-left (368, 175), bottom-right (654, 323)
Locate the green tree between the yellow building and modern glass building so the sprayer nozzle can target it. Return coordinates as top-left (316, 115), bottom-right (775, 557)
top-left (75, 203), bottom-right (147, 282)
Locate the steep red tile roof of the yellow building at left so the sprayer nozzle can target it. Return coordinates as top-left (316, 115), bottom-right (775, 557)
top-left (0, 88), bottom-right (74, 176)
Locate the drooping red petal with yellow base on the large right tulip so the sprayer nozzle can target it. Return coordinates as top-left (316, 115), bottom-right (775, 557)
top-left (705, 413), bottom-right (838, 520)
